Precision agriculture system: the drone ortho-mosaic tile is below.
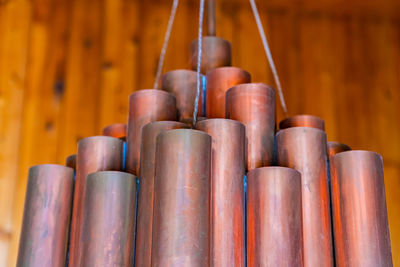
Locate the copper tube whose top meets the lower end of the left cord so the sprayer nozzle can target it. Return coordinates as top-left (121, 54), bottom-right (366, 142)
top-left (126, 89), bottom-right (177, 175)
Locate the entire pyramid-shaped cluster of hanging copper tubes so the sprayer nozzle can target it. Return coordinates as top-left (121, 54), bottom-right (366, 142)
top-left (18, 4), bottom-right (392, 267)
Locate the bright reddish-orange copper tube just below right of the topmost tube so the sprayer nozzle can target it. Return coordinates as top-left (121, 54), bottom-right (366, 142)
top-left (206, 67), bottom-right (251, 118)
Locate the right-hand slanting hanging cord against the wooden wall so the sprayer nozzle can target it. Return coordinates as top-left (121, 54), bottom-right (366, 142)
top-left (250, 0), bottom-right (288, 117)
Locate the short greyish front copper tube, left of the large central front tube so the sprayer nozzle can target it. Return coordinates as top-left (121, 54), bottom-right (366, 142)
top-left (79, 171), bottom-right (136, 266)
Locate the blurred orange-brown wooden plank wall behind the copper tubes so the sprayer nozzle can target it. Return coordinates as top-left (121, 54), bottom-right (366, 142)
top-left (0, 0), bottom-right (400, 266)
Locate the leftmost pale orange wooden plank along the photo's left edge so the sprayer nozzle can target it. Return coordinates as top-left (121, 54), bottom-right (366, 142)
top-left (0, 0), bottom-right (31, 266)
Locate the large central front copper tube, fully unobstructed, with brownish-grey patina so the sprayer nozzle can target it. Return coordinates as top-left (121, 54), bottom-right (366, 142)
top-left (151, 129), bottom-right (211, 267)
